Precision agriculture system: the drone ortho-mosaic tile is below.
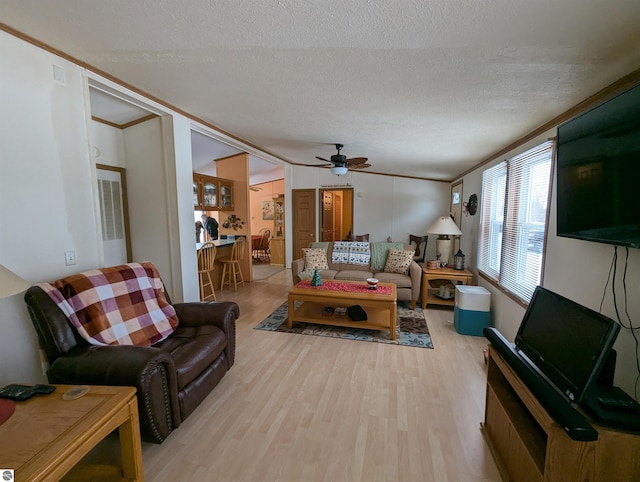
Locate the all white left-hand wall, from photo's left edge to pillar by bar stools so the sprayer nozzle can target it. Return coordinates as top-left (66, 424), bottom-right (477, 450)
top-left (0, 31), bottom-right (198, 385)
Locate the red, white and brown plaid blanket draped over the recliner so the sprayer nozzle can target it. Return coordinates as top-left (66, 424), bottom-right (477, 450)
top-left (38, 262), bottom-right (178, 346)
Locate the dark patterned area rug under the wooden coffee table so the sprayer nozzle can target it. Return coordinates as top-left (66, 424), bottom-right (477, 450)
top-left (254, 303), bottom-right (433, 348)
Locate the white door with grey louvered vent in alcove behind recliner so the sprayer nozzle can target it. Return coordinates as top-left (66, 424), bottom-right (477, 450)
top-left (96, 164), bottom-right (131, 266)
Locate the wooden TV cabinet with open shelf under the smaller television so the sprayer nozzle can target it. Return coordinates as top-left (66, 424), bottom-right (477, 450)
top-left (483, 347), bottom-right (640, 482)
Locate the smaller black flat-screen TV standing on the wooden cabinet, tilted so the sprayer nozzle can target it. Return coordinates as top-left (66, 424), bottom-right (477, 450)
top-left (515, 286), bottom-right (620, 403)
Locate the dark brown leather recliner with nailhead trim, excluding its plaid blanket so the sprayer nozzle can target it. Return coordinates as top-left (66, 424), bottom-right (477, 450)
top-left (24, 286), bottom-right (240, 443)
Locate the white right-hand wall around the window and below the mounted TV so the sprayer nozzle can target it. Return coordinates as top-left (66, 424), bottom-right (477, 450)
top-left (462, 129), bottom-right (640, 396)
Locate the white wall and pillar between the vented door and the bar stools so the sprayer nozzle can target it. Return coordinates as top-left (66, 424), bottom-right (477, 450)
top-left (91, 115), bottom-right (199, 301)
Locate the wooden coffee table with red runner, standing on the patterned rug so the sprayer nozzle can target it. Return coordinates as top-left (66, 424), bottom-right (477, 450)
top-left (287, 281), bottom-right (397, 340)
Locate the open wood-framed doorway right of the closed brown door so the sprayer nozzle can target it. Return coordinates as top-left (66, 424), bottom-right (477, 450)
top-left (320, 188), bottom-right (353, 241)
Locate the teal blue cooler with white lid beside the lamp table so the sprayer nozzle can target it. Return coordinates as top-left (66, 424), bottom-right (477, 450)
top-left (453, 285), bottom-right (491, 336)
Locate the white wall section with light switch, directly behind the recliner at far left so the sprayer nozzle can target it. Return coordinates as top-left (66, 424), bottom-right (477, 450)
top-left (0, 32), bottom-right (99, 384)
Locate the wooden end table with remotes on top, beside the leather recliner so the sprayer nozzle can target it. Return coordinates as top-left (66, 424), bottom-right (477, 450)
top-left (0, 385), bottom-right (144, 481)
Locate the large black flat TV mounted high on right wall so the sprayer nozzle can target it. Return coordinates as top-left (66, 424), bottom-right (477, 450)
top-left (557, 84), bottom-right (640, 248)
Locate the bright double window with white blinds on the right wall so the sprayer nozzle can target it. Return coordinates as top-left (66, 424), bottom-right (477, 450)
top-left (478, 141), bottom-right (553, 303)
